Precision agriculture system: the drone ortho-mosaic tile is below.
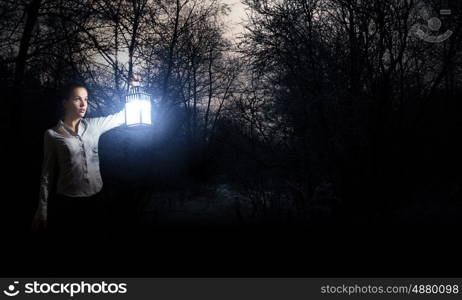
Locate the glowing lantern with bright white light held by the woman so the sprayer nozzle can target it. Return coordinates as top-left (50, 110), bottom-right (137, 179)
top-left (125, 81), bottom-right (151, 126)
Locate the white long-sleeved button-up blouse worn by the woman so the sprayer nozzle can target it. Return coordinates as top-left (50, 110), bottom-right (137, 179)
top-left (35, 109), bottom-right (125, 220)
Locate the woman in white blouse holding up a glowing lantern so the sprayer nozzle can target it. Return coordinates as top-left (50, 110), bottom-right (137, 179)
top-left (32, 77), bottom-right (132, 234)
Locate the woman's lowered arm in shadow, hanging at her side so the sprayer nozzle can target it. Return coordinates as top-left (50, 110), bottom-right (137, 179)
top-left (34, 130), bottom-right (56, 226)
